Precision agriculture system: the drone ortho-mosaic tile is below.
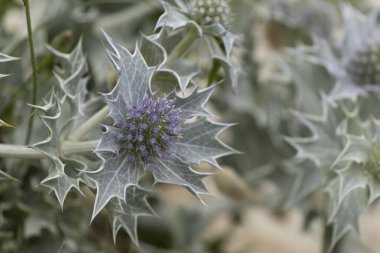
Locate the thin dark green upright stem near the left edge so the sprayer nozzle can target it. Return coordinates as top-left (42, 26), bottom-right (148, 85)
top-left (23, 0), bottom-right (37, 144)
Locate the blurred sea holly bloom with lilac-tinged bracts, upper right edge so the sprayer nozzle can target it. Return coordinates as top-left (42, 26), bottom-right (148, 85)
top-left (296, 5), bottom-right (380, 100)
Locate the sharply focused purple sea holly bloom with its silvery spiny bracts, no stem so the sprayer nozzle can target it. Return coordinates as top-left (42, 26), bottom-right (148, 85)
top-left (87, 35), bottom-right (233, 242)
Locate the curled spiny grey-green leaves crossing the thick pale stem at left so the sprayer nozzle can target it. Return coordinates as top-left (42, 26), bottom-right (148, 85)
top-left (32, 40), bottom-right (88, 207)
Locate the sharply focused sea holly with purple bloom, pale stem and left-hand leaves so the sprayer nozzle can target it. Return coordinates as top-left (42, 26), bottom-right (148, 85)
top-left (0, 25), bottom-right (234, 247)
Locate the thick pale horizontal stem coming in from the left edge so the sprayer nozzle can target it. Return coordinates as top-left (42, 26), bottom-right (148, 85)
top-left (0, 140), bottom-right (99, 159)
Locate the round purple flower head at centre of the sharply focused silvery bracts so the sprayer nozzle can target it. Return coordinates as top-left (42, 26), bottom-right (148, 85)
top-left (118, 97), bottom-right (183, 162)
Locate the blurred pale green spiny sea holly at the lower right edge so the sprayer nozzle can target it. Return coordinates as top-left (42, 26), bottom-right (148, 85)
top-left (287, 93), bottom-right (380, 245)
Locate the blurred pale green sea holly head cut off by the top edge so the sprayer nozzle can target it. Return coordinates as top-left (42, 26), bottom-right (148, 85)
top-left (153, 0), bottom-right (240, 89)
